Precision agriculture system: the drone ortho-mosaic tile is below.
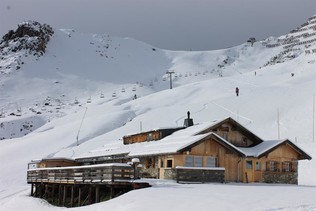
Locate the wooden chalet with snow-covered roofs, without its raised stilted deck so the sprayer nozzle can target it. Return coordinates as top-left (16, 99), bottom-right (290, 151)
top-left (76, 116), bottom-right (312, 184)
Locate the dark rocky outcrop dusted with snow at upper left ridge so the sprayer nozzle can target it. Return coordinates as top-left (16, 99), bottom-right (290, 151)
top-left (0, 21), bottom-right (54, 56)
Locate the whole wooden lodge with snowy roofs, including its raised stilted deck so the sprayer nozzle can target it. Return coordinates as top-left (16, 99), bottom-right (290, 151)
top-left (27, 112), bottom-right (312, 207)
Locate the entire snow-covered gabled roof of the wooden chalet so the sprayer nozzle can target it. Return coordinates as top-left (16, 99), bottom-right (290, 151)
top-left (77, 118), bottom-right (311, 162)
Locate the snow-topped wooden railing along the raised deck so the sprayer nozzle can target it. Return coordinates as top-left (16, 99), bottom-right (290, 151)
top-left (27, 163), bottom-right (134, 183)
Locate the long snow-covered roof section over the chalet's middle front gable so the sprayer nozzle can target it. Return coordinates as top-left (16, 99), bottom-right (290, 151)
top-left (77, 122), bottom-right (245, 159)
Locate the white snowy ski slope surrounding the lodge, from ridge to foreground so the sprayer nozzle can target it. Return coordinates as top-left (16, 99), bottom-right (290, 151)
top-left (0, 17), bottom-right (316, 210)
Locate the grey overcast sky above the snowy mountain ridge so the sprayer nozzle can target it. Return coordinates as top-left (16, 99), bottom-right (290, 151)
top-left (0, 0), bottom-right (316, 50)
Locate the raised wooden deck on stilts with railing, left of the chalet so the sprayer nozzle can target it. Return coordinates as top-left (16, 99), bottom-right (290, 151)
top-left (27, 163), bottom-right (150, 207)
